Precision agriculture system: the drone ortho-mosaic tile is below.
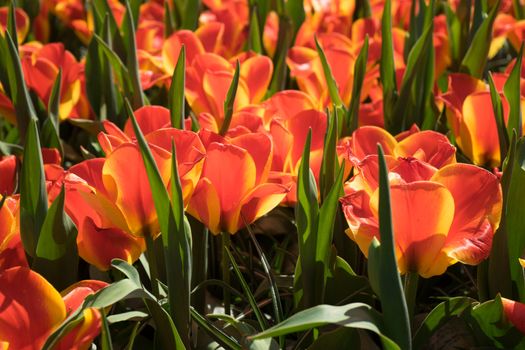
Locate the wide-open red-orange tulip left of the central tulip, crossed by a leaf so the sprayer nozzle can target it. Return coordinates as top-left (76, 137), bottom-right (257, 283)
top-left (66, 143), bottom-right (171, 270)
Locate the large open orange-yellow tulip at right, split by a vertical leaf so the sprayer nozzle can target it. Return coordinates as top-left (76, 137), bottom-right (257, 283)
top-left (341, 155), bottom-right (502, 278)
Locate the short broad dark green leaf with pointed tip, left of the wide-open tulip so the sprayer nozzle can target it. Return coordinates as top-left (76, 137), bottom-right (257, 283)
top-left (32, 187), bottom-right (78, 290)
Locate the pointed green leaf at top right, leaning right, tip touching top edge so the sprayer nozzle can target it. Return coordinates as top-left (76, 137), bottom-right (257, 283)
top-left (460, 0), bottom-right (499, 79)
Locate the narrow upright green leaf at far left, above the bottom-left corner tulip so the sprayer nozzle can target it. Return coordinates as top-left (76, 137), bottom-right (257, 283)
top-left (20, 119), bottom-right (47, 257)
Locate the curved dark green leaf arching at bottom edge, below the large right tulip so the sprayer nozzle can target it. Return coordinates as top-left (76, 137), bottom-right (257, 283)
top-left (412, 297), bottom-right (477, 350)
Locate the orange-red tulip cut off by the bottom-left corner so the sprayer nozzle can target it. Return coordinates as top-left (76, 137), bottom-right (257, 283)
top-left (0, 267), bottom-right (107, 350)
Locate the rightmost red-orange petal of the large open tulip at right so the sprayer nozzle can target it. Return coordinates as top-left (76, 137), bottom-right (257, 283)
top-left (431, 164), bottom-right (502, 265)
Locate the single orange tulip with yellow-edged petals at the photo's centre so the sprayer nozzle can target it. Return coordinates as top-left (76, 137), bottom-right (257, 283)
top-left (188, 131), bottom-right (288, 234)
